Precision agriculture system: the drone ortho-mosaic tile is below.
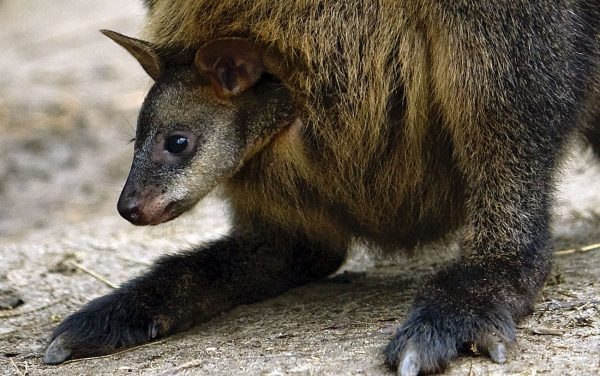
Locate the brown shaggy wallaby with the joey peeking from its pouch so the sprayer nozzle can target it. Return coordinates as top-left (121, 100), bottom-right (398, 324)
top-left (44, 0), bottom-right (600, 375)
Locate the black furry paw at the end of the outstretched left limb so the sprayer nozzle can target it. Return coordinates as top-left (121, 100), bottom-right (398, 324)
top-left (44, 292), bottom-right (168, 364)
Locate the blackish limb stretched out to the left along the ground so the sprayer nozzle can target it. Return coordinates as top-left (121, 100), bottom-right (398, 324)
top-left (44, 225), bottom-right (346, 364)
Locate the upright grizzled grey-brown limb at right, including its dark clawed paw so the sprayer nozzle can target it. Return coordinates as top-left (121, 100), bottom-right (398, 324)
top-left (385, 9), bottom-right (580, 376)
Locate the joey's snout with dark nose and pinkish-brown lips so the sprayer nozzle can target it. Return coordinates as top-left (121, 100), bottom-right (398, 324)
top-left (117, 184), bottom-right (180, 226)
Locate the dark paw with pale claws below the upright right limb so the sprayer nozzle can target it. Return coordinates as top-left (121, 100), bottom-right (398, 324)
top-left (385, 266), bottom-right (515, 376)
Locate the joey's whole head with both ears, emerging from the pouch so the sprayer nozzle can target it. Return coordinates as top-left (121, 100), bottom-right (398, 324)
top-left (102, 31), bottom-right (295, 225)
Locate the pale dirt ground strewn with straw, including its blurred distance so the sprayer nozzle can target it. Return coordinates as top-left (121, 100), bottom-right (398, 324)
top-left (0, 0), bottom-right (600, 375)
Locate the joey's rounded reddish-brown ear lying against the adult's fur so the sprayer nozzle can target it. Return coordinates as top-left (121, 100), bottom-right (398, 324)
top-left (195, 38), bottom-right (265, 98)
